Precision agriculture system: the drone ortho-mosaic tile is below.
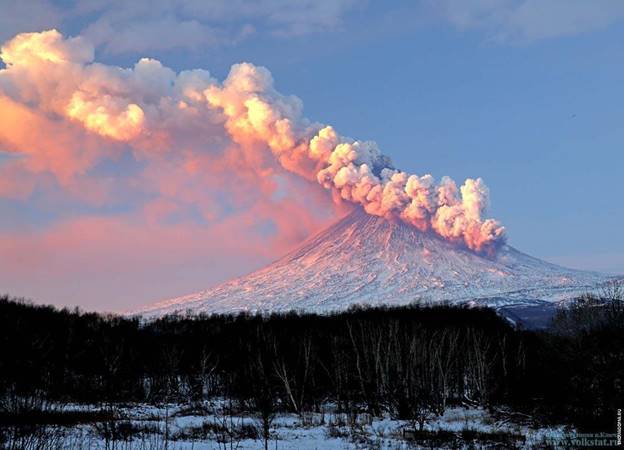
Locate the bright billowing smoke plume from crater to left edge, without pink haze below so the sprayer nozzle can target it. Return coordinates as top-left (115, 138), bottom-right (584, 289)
top-left (0, 30), bottom-right (505, 252)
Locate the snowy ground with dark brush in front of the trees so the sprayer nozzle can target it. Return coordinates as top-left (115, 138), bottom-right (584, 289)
top-left (5, 402), bottom-right (571, 450)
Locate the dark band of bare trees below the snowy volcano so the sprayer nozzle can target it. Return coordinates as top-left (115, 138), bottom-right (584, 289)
top-left (0, 288), bottom-right (624, 431)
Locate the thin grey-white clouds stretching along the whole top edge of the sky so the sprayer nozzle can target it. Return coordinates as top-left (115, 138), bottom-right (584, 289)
top-left (0, 0), bottom-right (624, 54)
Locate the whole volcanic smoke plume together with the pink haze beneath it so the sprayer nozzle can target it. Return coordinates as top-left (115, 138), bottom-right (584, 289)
top-left (0, 30), bottom-right (504, 310)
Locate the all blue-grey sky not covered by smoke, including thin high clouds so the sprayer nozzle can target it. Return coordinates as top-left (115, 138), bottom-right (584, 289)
top-left (0, 0), bottom-right (624, 309)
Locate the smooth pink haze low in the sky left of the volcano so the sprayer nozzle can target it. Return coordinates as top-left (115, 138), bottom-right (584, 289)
top-left (0, 215), bottom-right (274, 311)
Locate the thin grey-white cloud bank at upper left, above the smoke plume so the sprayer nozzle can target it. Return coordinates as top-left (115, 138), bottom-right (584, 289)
top-left (0, 0), bottom-right (356, 54)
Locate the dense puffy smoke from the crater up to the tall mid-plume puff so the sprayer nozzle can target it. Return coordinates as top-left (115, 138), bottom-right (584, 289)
top-left (204, 59), bottom-right (505, 252)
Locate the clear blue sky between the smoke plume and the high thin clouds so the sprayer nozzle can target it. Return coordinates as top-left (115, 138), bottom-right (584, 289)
top-left (105, 2), bottom-right (624, 273)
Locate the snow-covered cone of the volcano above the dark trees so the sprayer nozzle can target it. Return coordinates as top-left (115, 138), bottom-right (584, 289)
top-left (138, 210), bottom-right (609, 317)
